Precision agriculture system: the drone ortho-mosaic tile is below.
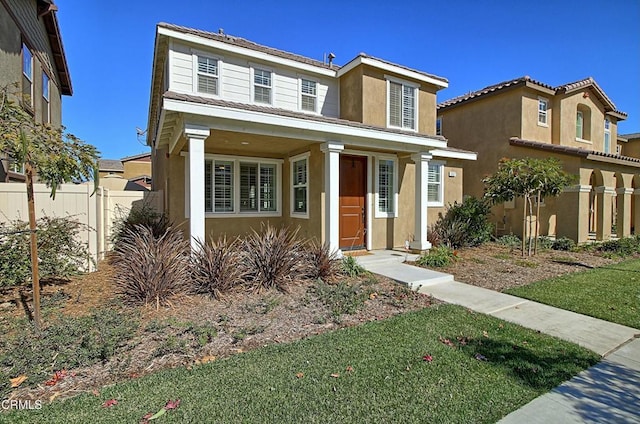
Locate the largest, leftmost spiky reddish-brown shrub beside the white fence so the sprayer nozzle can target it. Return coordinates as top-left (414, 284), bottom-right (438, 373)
top-left (114, 225), bottom-right (190, 308)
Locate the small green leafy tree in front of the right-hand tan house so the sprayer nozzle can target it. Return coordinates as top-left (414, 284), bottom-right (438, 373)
top-left (482, 158), bottom-right (574, 256)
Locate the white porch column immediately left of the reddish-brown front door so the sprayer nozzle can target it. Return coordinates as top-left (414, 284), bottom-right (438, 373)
top-left (320, 141), bottom-right (344, 252)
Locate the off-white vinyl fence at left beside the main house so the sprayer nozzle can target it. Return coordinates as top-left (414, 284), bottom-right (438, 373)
top-left (0, 183), bottom-right (162, 271)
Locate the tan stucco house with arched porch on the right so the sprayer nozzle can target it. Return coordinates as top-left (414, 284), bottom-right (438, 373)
top-left (438, 77), bottom-right (640, 242)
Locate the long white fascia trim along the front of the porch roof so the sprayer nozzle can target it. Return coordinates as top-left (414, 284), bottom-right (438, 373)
top-left (163, 99), bottom-right (447, 148)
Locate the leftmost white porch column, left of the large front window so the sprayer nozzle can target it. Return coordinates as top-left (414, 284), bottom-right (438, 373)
top-left (185, 127), bottom-right (209, 250)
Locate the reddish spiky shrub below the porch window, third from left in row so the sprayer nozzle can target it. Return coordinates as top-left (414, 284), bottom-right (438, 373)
top-left (242, 224), bottom-right (308, 291)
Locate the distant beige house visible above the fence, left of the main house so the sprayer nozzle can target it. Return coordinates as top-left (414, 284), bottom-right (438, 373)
top-left (98, 153), bottom-right (152, 190)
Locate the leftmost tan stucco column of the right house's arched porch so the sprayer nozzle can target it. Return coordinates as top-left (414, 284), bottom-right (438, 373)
top-left (556, 185), bottom-right (591, 243)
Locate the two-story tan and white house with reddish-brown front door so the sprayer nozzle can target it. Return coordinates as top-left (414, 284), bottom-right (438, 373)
top-left (148, 23), bottom-right (476, 250)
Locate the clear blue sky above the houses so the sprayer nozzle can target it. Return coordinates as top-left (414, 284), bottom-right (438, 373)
top-left (56, 0), bottom-right (640, 159)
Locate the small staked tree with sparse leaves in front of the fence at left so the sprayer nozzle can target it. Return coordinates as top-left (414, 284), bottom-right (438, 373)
top-left (0, 84), bottom-right (98, 328)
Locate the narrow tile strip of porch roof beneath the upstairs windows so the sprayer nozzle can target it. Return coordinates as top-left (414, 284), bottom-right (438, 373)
top-left (163, 91), bottom-right (446, 141)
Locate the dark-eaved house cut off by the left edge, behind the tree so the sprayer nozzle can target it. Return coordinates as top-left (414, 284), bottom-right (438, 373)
top-left (0, 0), bottom-right (73, 182)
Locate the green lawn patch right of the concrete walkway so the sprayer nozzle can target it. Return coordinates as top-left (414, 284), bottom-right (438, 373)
top-left (505, 259), bottom-right (640, 328)
